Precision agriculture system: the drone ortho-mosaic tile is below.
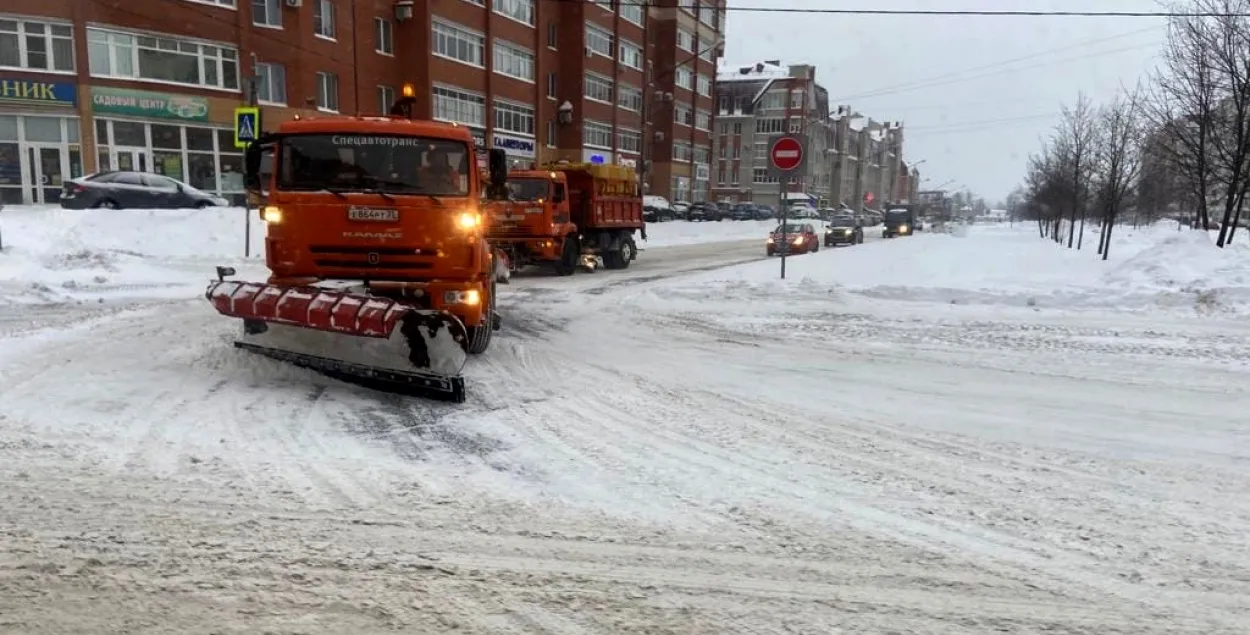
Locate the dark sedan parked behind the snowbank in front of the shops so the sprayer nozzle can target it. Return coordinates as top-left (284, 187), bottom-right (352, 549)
top-left (61, 170), bottom-right (229, 210)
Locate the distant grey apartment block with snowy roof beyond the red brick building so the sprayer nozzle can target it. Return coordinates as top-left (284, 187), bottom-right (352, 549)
top-left (713, 60), bottom-right (919, 209)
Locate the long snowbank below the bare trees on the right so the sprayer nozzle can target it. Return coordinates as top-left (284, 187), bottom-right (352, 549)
top-left (654, 225), bottom-right (1250, 313)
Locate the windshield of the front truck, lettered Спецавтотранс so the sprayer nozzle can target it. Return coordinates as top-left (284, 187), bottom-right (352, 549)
top-left (278, 133), bottom-right (470, 196)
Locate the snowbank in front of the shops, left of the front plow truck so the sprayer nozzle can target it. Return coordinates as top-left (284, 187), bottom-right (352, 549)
top-left (0, 208), bottom-right (264, 304)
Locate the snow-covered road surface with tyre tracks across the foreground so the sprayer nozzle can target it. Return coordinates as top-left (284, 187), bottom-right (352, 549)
top-left (0, 226), bottom-right (1250, 635)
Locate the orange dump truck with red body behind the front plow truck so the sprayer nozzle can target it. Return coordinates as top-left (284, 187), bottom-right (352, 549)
top-left (486, 161), bottom-right (646, 275)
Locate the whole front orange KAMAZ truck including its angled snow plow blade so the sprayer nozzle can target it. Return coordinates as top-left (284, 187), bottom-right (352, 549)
top-left (206, 85), bottom-right (508, 401)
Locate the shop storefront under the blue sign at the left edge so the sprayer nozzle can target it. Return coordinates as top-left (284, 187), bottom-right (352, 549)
top-left (0, 75), bottom-right (83, 205)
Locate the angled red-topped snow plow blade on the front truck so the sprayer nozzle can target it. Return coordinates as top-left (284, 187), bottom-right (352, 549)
top-left (205, 273), bottom-right (468, 403)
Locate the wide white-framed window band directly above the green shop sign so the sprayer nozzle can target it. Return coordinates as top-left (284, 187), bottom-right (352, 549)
top-left (86, 29), bottom-right (239, 90)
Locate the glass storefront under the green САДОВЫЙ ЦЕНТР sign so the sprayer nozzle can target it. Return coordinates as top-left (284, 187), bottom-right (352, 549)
top-left (91, 86), bottom-right (244, 204)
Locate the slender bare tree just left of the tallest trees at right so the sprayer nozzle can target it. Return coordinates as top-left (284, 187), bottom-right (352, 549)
top-left (1094, 90), bottom-right (1143, 260)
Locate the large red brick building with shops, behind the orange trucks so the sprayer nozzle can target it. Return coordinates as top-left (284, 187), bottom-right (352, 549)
top-left (0, 0), bottom-right (724, 203)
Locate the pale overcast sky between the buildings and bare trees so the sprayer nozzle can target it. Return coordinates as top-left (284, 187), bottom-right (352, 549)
top-left (725, 0), bottom-right (1165, 203)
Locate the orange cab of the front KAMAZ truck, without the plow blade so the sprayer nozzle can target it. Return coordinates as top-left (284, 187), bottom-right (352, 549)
top-left (245, 91), bottom-right (504, 353)
